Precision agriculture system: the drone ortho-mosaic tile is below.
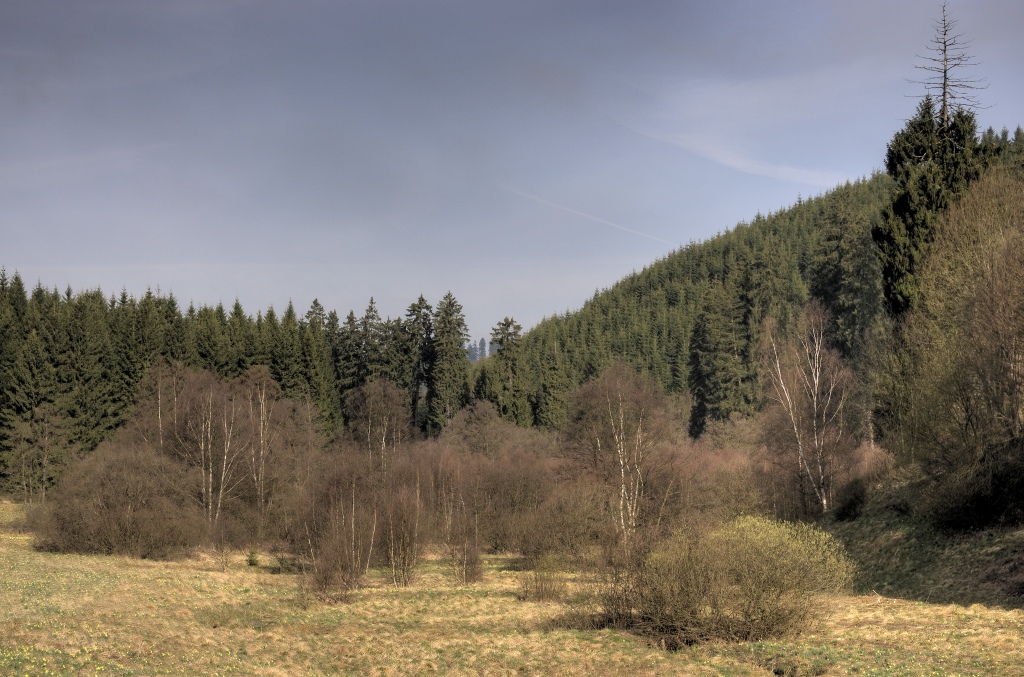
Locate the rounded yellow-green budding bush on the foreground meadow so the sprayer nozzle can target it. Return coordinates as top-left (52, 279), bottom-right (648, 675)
top-left (634, 517), bottom-right (853, 643)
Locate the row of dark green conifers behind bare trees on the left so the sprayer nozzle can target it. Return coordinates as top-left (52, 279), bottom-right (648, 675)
top-left (0, 282), bottom-right (470, 501)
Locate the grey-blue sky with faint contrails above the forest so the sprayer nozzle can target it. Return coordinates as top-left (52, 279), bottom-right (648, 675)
top-left (0, 0), bottom-right (1024, 338)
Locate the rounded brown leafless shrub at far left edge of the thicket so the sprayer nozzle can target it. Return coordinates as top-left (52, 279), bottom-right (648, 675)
top-left (38, 442), bottom-right (205, 558)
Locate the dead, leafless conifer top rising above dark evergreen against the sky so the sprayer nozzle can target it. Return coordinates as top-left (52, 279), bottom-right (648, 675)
top-left (914, 2), bottom-right (988, 127)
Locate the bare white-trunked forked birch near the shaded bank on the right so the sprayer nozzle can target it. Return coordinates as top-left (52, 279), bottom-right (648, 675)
top-left (762, 302), bottom-right (856, 512)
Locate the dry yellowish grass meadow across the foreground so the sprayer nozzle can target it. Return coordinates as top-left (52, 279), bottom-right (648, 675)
top-left (0, 504), bottom-right (1024, 675)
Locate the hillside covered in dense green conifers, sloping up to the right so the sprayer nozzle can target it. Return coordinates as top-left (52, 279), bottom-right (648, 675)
top-left (523, 173), bottom-right (892, 425)
